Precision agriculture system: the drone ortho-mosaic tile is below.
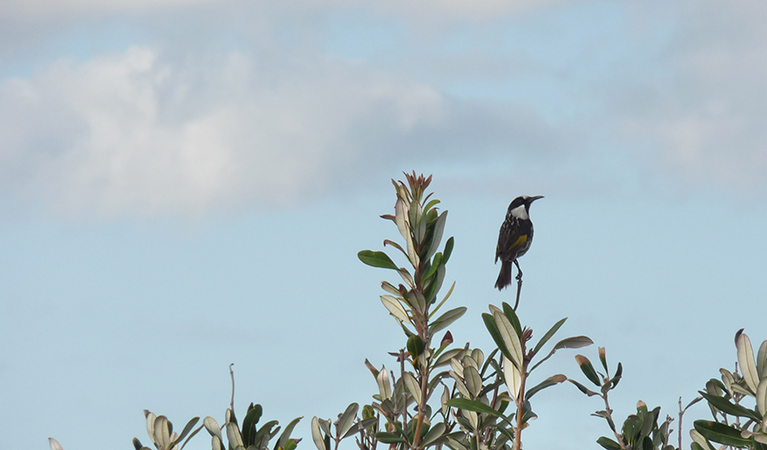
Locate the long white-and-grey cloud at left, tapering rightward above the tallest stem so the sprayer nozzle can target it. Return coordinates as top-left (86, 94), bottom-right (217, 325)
top-left (0, 47), bottom-right (555, 215)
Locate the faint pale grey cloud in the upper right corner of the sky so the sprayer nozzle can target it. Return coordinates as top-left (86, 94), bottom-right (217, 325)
top-left (612, 1), bottom-right (767, 194)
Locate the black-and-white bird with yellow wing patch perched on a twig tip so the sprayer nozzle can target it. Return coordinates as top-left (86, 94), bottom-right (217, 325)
top-left (495, 195), bottom-right (543, 291)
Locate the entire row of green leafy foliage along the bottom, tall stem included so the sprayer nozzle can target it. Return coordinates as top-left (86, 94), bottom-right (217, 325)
top-left (49, 172), bottom-right (767, 450)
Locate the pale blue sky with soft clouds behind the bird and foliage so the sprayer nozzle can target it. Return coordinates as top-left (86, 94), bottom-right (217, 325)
top-left (0, 0), bottom-right (767, 450)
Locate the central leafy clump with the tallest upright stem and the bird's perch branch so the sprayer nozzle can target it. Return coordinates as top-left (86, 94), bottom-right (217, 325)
top-left (312, 173), bottom-right (591, 450)
